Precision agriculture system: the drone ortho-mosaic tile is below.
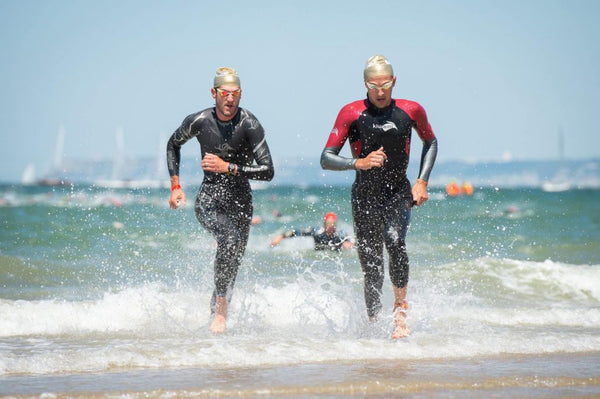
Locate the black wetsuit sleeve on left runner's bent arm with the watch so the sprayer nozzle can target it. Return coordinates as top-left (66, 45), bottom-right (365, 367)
top-left (238, 115), bottom-right (275, 181)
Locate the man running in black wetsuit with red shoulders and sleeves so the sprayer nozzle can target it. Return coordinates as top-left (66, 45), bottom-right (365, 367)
top-left (321, 56), bottom-right (437, 338)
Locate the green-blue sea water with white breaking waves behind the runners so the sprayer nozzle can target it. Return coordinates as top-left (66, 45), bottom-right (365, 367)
top-left (0, 185), bottom-right (600, 378)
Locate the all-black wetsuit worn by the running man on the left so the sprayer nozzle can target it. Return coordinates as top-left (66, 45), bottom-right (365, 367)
top-left (167, 107), bottom-right (274, 312)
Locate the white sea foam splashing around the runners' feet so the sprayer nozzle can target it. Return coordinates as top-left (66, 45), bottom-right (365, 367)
top-left (0, 258), bottom-right (600, 375)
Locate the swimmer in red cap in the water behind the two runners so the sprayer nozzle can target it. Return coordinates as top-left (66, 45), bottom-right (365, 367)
top-left (271, 212), bottom-right (354, 251)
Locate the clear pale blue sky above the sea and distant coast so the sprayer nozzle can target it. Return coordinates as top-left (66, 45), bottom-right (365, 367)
top-left (0, 0), bottom-right (600, 181)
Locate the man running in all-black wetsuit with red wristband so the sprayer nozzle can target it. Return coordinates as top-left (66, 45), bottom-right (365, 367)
top-left (167, 68), bottom-right (274, 333)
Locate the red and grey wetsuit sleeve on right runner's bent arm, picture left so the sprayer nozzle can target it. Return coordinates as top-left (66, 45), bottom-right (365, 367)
top-left (321, 103), bottom-right (360, 170)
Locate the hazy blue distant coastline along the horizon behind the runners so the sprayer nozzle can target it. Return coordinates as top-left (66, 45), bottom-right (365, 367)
top-left (9, 157), bottom-right (600, 189)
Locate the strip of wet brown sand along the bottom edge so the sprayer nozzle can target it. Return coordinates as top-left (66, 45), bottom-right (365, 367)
top-left (0, 352), bottom-right (600, 398)
